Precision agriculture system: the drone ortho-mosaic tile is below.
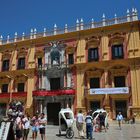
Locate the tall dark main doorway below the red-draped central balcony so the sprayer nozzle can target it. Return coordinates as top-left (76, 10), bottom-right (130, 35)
top-left (47, 102), bottom-right (61, 125)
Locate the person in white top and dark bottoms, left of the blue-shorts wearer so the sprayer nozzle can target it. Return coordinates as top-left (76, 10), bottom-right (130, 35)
top-left (22, 114), bottom-right (30, 140)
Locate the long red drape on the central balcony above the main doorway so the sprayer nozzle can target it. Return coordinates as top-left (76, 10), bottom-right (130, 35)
top-left (33, 89), bottom-right (75, 96)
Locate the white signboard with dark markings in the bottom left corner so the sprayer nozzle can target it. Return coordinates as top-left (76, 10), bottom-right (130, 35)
top-left (0, 122), bottom-right (11, 140)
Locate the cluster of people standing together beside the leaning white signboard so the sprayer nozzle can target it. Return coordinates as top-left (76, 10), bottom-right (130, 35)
top-left (7, 101), bottom-right (47, 140)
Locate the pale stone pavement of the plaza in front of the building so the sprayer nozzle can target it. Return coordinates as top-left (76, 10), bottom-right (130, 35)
top-left (29, 122), bottom-right (140, 140)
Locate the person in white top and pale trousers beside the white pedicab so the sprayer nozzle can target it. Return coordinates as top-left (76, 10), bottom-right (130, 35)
top-left (76, 110), bottom-right (84, 138)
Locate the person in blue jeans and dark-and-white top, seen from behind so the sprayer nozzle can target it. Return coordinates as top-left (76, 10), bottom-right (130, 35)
top-left (85, 112), bottom-right (93, 140)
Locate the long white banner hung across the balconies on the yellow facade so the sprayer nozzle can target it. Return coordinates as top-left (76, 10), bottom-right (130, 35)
top-left (90, 87), bottom-right (129, 94)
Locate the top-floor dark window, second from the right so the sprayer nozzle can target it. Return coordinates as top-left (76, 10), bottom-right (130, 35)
top-left (88, 48), bottom-right (99, 62)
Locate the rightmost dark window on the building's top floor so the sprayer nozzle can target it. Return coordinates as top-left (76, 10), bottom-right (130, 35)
top-left (112, 44), bottom-right (124, 59)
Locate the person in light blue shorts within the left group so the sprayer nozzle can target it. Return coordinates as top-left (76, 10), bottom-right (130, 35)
top-left (31, 115), bottom-right (39, 140)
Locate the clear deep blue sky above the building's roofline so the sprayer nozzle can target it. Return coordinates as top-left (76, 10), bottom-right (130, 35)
top-left (0, 0), bottom-right (140, 38)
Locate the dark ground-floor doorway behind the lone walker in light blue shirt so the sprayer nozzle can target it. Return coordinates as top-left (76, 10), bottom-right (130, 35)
top-left (115, 100), bottom-right (127, 118)
